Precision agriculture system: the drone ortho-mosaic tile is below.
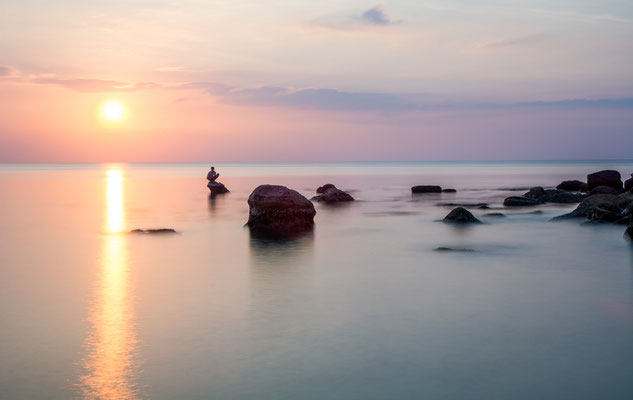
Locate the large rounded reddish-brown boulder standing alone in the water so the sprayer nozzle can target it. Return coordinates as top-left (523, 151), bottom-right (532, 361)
top-left (246, 185), bottom-right (316, 237)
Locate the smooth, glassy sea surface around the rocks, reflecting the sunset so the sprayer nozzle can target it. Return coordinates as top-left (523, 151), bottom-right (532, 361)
top-left (0, 162), bottom-right (633, 400)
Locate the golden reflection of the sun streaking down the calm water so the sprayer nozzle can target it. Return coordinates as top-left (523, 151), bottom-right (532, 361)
top-left (80, 167), bottom-right (142, 400)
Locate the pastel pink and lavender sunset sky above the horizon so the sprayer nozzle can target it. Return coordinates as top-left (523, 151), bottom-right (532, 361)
top-left (0, 0), bottom-right (633, 162)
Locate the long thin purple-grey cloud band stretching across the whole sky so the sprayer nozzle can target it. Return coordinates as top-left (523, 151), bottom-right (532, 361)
top-left (0, 65), bottom-right (633, 112)
